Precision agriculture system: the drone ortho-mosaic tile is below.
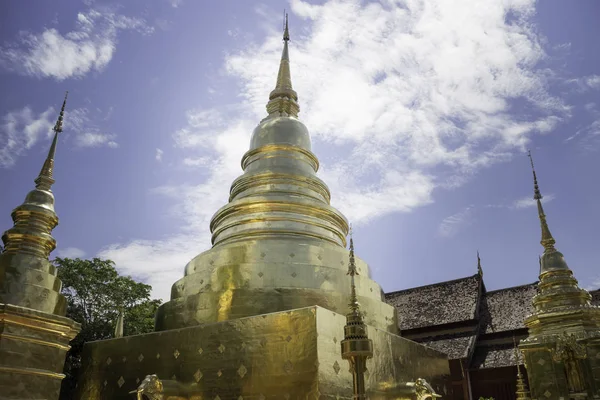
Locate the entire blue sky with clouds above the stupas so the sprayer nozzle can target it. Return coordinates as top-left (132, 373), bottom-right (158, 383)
top-left (0, 0), bottom-right (600, 300)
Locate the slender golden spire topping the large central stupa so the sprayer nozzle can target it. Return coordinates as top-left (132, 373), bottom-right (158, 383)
top-left (267, 14), bottom-right (300, 118)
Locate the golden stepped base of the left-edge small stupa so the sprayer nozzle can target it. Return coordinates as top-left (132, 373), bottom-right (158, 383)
top-left (0, 303), bottom-right (79, 400)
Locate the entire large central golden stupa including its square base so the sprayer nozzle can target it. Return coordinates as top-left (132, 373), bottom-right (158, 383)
top-left (78, 17), bottom-right (450, 400)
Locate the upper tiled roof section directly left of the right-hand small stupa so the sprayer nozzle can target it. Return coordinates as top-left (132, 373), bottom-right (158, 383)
top-left (480, 283), bottom-right (537, 334)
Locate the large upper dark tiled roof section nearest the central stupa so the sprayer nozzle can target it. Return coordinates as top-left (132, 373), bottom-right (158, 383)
top-left (385, 275), bottom-right (480, 331)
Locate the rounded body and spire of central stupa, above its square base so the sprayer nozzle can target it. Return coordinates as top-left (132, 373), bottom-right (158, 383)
top-left (156, 25), bottom-right (398, 333)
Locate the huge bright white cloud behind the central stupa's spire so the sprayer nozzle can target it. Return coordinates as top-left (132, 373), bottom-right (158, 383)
top-left (100, 0), bottom-right (569, 298)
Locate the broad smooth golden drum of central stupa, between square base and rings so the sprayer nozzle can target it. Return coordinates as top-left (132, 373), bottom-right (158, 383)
top-left (156, 238), bottom-right (398, 333)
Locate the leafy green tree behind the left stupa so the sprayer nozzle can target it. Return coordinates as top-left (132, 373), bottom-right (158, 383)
top-left (54, 257), bottom-right (161, 399)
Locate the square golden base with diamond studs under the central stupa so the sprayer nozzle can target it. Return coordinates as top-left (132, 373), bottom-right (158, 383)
top-left (76, 306), bottom-right (449, 400)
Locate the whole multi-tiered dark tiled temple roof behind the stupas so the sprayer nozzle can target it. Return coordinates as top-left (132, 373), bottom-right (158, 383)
top-left (385, 275), bottom-right (600, 368)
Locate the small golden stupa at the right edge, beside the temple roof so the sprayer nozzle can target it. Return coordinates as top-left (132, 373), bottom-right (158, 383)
top-left (519, 154), bottom-right (600, 400)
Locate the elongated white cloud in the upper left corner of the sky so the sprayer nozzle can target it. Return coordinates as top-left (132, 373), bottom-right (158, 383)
top-left (0, 9), bottom-right (152, 81)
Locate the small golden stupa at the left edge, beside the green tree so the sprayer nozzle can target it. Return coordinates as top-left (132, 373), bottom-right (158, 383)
top-left (0, 91), bottom-right (80, 400)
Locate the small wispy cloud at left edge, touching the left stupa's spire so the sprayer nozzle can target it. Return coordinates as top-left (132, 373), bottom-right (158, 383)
top-left (0, 106), bottom-right (56, 168)
